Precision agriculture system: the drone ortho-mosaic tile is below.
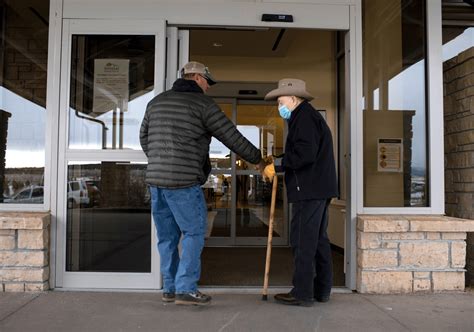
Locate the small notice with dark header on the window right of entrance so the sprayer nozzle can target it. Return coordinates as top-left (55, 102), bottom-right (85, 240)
top-left (377, 138), bottom-right (403, 172)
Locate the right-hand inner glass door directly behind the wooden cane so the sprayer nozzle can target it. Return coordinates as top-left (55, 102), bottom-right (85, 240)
top-left (235, 101), bottom-right (288, 245)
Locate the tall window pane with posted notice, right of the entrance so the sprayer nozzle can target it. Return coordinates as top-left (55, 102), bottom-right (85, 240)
top-left (363, 0), bottom-right (429, 207)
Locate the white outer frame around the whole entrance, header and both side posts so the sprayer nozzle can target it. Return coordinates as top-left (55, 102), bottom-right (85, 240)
top-left (46, 0), bottom-right (362, 289)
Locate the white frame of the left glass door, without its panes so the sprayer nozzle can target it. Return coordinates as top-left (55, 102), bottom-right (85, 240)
top-left (53, 19), bottom-right (166, 289)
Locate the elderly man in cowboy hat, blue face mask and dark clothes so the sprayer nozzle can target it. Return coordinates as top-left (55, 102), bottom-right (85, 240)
top-left (263, 79), bottom-right (337, 306)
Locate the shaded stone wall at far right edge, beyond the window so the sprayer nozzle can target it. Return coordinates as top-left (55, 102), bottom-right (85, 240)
top-left (443, 47), bottom-right (474, 286)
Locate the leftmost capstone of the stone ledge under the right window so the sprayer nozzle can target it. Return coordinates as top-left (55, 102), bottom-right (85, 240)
top-left (357, 215), bottom-right (410, 233)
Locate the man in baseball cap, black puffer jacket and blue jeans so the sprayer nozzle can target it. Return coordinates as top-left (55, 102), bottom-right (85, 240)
top-left (140, 62), bottom-right (263, 305)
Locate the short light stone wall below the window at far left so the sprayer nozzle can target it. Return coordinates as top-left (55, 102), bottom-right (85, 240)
top-left (0, 212), bottom-right (50, 292)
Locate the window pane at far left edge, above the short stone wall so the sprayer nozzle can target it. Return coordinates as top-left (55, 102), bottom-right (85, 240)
top-left (0, 0), bottom-right (49, 204)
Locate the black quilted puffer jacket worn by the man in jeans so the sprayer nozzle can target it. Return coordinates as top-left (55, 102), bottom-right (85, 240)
top-left (140, 79), bottom-right (261, 188)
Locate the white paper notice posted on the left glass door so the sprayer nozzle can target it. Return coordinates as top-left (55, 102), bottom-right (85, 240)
top-left (93, 59), bottom-right (130, 113)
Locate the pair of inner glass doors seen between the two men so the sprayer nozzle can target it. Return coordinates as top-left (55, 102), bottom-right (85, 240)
top-left (203, 99), bottom-right (288, 246)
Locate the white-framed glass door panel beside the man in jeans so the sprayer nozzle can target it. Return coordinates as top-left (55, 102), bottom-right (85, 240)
top-left (56, 20), bottom-right (166, 289)
